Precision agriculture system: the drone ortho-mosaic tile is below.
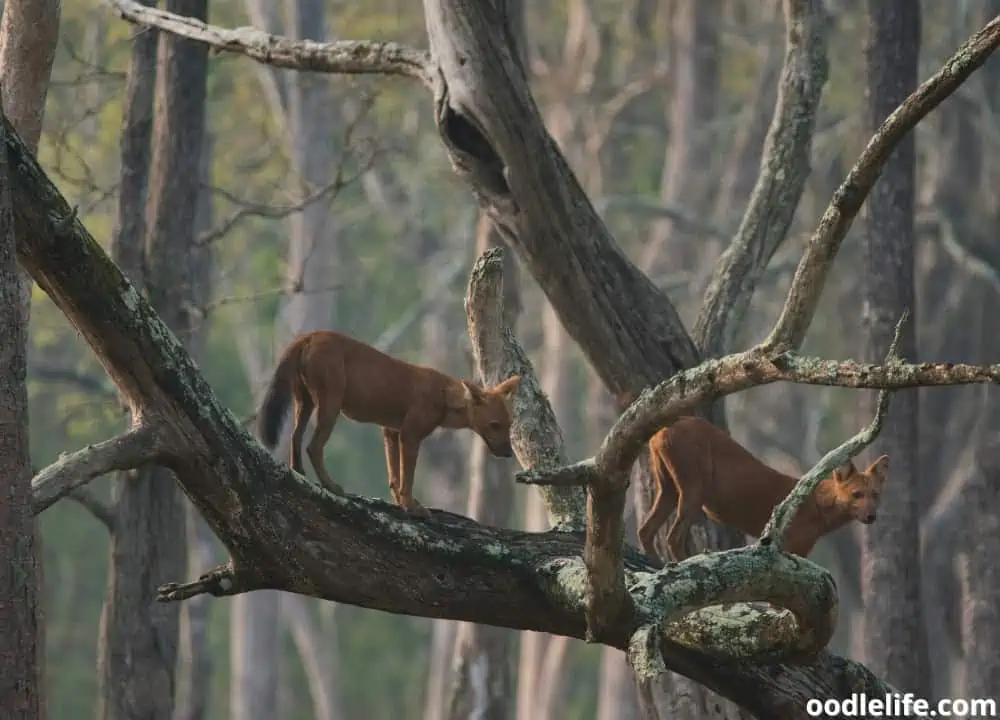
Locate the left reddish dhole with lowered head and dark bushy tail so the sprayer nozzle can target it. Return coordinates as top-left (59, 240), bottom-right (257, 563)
top-left (257, 331), bottom-right (520, 515)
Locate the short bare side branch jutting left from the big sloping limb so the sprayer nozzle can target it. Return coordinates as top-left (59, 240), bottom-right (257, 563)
top-left (31, 425), bottom-right (162, 515)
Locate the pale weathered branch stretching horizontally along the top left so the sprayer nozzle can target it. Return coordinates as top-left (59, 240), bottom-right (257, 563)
top-left (105, 0), bottom-right (430, 85)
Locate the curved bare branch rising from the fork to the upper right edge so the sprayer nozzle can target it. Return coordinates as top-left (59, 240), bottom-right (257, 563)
top-left (763, 17), bottom-right (1000, 351)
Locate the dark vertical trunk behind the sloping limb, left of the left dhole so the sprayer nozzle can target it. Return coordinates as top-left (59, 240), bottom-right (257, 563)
top-left (100, 0), bottom-right (211, 720)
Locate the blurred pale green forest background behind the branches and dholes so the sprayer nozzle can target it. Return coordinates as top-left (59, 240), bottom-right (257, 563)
top-left (21, 0), bottom-right (1000, 720)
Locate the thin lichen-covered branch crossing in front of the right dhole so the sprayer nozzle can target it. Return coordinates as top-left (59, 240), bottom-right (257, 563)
top-left (760, 310), bottom-right (910, 548)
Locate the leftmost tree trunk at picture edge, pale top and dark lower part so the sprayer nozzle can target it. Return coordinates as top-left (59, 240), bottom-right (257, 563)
top-left (0, 0), bottom-right (62, 718)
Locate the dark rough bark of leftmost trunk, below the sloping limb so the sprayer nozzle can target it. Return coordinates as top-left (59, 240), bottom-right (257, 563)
top-left (0, 100), bottom-right (43, 720)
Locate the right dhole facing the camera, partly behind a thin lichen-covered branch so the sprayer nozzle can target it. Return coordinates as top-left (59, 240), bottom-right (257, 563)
top-left (638, 417), bottom-right (889, 562)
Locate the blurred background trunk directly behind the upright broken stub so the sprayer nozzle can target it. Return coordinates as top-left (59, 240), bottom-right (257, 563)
top-left (444, 213), bottom-right (520, 720)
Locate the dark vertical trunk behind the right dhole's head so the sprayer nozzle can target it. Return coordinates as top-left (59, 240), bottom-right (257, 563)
top-left (861, 0), bottom-right (931, 696)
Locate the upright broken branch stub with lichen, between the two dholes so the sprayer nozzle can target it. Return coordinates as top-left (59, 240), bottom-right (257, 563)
top-left (465, 247), bottom-right (586, 532)
